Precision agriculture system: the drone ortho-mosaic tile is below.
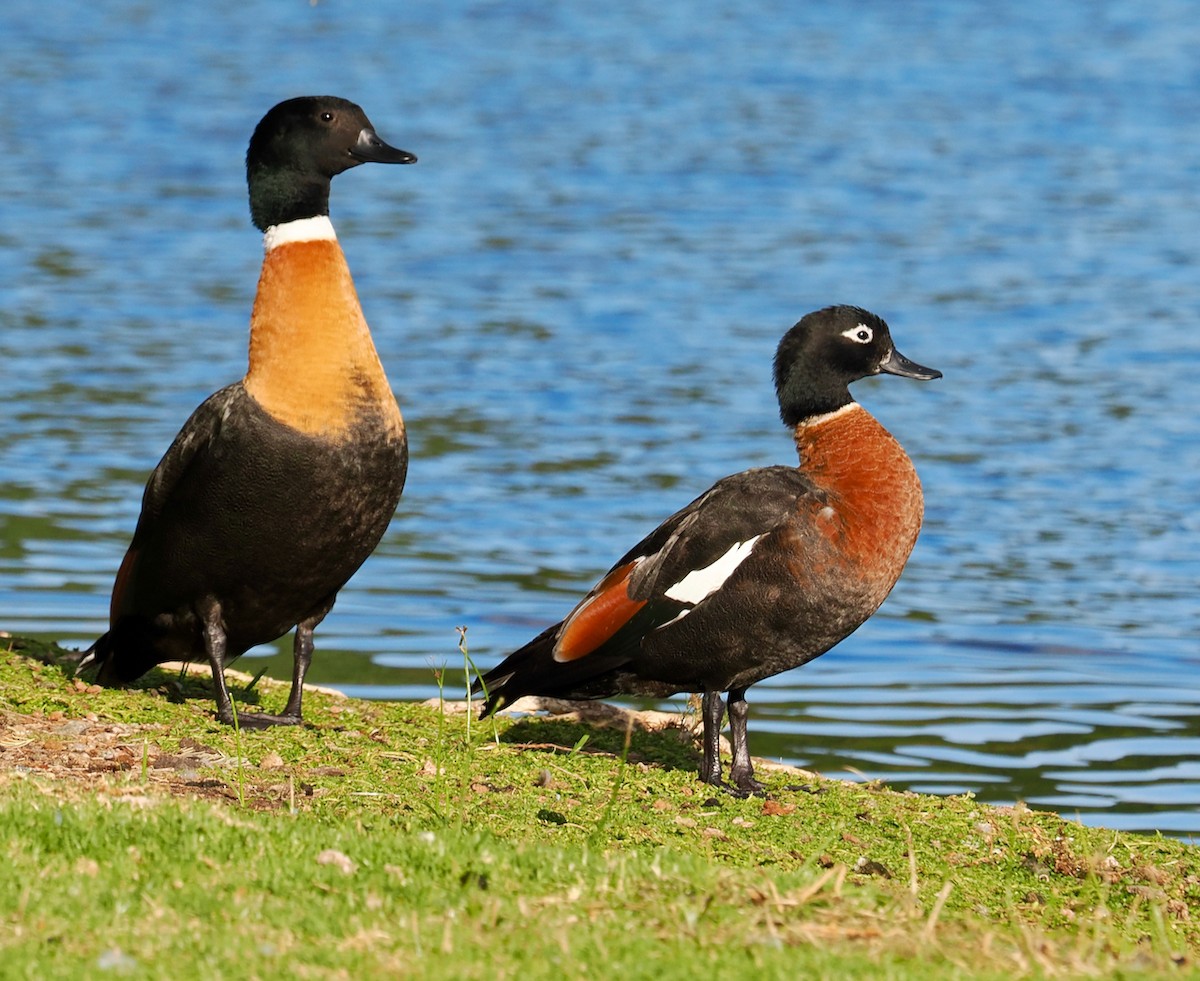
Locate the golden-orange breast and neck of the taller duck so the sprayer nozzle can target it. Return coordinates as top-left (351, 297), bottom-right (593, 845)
top-left (244, 240), bottom-right (403, 440)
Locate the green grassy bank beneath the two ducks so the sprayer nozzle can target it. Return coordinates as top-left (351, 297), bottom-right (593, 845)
top-left (0, 640), bottom-right (1200, 979)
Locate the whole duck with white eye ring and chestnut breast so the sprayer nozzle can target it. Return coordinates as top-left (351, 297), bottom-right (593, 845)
top-left (475, 306), bottom-right (941, 794)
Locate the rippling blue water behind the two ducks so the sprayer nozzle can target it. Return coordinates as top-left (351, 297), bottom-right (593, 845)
top-left (0, 0), bottom-right (1200, 835)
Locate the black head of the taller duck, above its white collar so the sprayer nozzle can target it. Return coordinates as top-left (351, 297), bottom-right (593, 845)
top-left (246, 96), bottom-right (416, 231)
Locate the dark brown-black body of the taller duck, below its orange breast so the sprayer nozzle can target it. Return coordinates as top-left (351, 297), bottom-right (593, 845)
top-left (90, 383), bottom-right (408, 681)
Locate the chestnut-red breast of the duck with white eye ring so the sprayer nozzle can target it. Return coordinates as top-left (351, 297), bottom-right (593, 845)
top-left (794, 403), bottom-right (924, 607)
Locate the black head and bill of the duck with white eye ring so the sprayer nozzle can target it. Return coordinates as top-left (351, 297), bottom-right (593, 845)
top-left (775, 307), bottom-right (942, 426)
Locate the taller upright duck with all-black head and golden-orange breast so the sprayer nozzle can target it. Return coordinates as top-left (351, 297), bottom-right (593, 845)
top-left (79, 96), bottom-right (416, 726)
